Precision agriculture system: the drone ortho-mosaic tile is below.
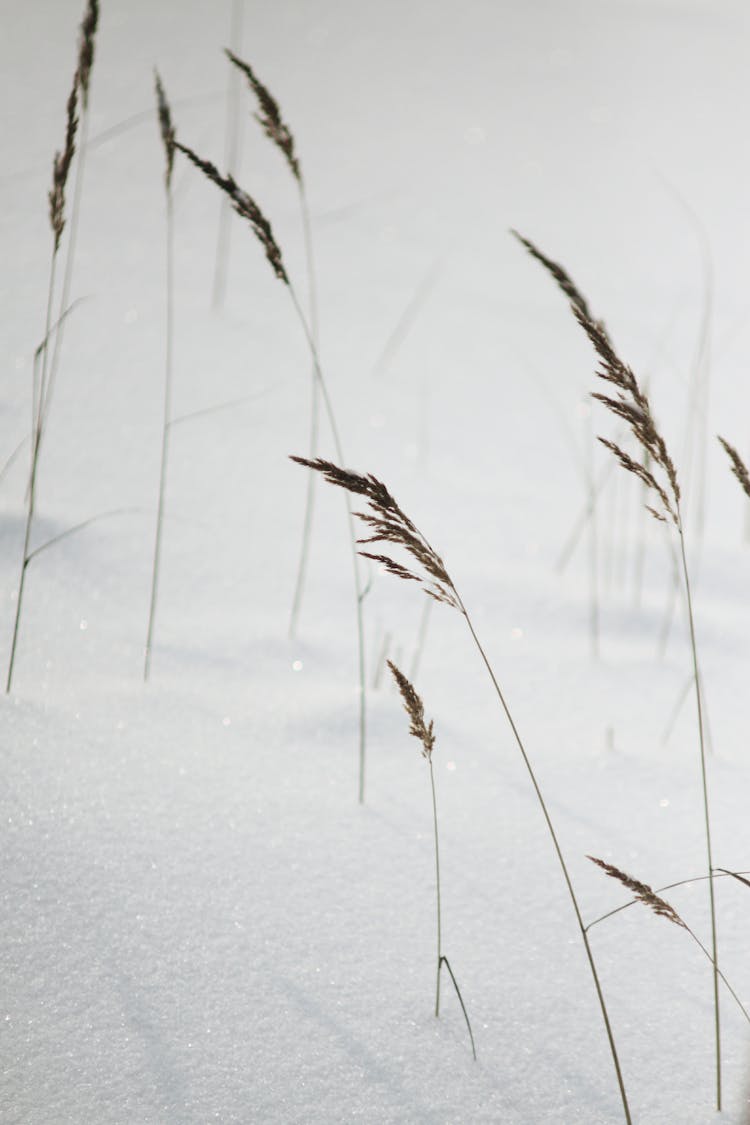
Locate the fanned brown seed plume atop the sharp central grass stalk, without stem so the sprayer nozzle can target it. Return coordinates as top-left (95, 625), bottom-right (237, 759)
top-left (291, 457), bottom-right (463, 612)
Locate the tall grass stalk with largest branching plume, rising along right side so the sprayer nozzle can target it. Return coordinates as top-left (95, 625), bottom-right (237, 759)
top-left (521, 232), bottom-right (722, 1110)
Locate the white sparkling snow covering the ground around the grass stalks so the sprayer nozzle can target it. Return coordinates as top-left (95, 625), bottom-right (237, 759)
top-left (0, 0), bottom-right (750, 1125)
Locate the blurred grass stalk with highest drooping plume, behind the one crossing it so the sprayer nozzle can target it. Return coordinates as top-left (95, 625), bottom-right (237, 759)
top-left (224, 50), bottom-right (320, 638)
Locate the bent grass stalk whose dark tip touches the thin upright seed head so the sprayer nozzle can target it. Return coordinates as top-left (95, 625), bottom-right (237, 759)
top-left (174, 141), bottom-right (369, 804)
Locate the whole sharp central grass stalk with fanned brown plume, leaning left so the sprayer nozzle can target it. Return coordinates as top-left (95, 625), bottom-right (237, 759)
top-left (291, 456), bottom-right (632, 1125)
